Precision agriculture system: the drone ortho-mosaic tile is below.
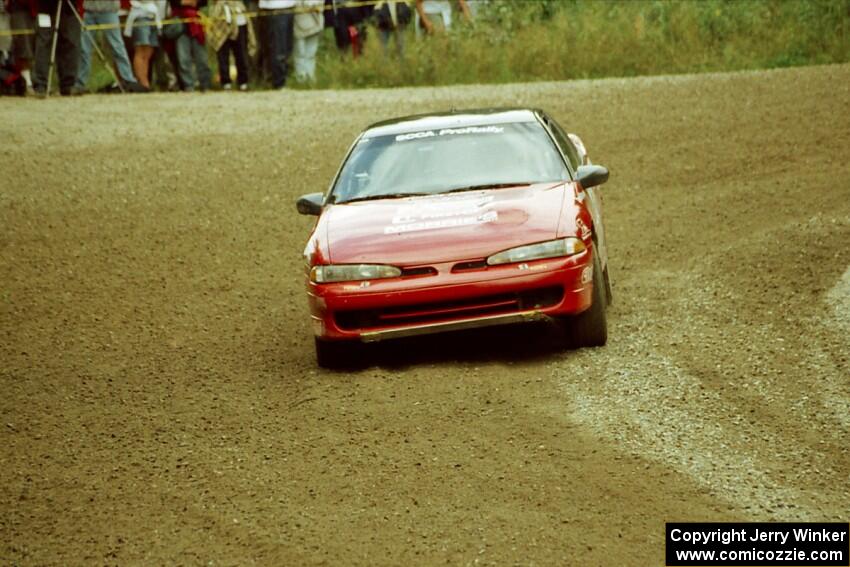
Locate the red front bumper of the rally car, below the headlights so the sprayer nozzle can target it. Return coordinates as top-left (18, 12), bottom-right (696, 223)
top-left (308, 248), bottom-right (593, 342)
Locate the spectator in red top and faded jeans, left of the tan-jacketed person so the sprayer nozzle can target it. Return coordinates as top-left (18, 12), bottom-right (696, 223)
top-left (171, 0), bottom-right (212, 92)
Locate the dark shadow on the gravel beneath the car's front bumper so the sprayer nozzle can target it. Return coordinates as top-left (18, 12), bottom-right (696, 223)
top-left (363, 324), bottom-right (566, 369)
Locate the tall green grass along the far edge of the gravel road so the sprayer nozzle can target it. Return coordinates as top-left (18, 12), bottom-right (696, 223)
top-left (84, 0), bottom-right (850, 88)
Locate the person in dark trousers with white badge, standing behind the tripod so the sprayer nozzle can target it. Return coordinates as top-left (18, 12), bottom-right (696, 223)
top-left (32, 0), bottom-right (83, 96)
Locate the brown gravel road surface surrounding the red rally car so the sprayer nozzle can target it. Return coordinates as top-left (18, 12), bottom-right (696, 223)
top-left (0, 66), bottom-right (850, 565)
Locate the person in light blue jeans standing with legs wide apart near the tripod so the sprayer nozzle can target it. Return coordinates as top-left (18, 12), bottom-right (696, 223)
top-left (76, 0), bottom-right (141, 92)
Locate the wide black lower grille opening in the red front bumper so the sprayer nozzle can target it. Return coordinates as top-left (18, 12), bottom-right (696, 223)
top-left (336, 286), bottom-right (564, 331)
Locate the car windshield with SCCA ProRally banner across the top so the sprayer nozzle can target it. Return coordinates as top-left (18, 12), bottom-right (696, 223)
top-left (333, 122), bottom-right (569, 203)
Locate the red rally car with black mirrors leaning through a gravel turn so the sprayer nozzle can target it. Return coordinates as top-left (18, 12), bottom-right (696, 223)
top-left (297, 109), bottom-right (611, 367)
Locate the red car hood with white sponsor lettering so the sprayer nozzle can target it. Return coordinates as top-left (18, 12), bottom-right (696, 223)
top-left (322, 183), bottom-right (570, 266)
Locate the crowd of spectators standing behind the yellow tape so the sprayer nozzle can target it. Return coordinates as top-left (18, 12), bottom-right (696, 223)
top-left (0, 0), bottom-right (474, 97)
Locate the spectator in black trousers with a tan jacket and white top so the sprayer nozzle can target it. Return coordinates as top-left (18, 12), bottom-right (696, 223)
top-left (207, 0), bottom-right (256, 91)
